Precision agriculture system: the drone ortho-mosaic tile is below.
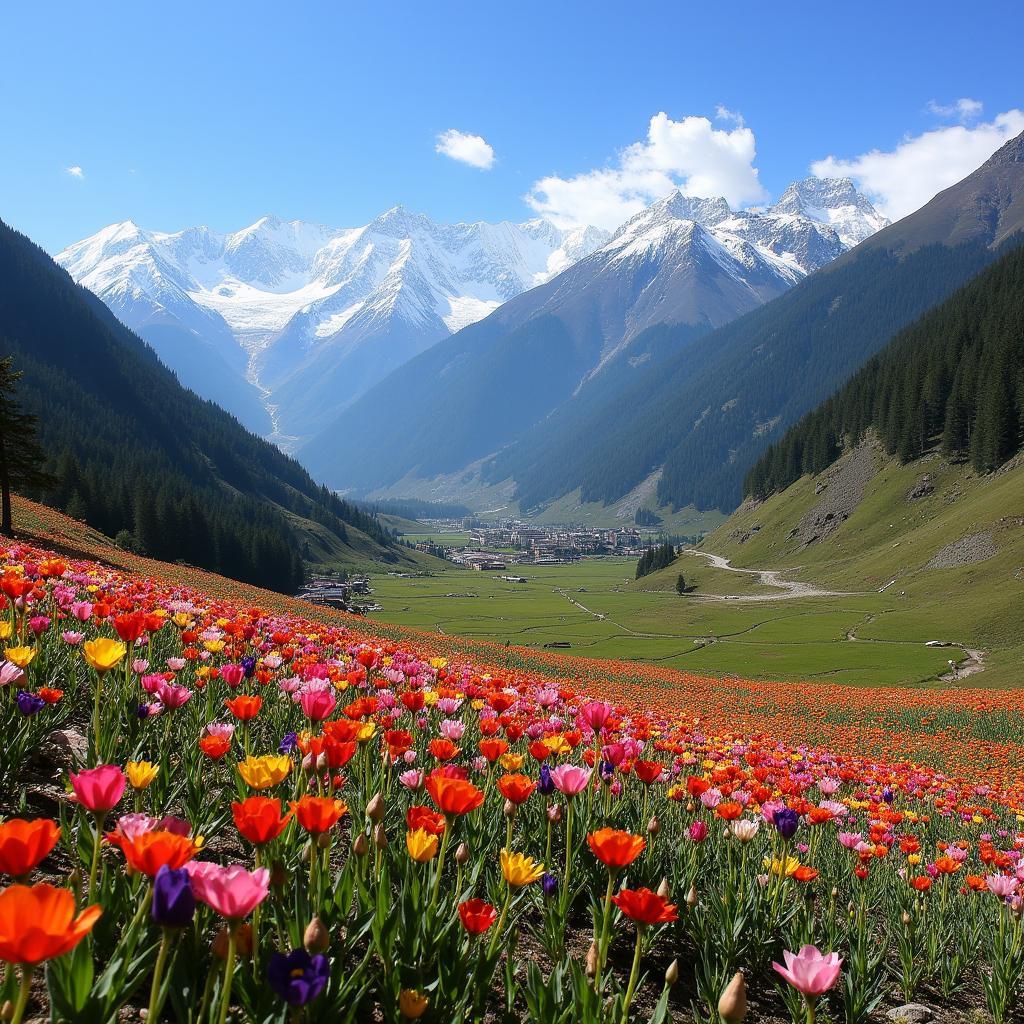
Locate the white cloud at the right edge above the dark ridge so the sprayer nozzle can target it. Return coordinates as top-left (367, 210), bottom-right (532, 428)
top-left (811, 109), bottom-right (1024, 220)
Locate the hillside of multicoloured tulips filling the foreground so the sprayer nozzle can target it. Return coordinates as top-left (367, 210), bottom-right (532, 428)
top-left (0, 524), bottom-right (1024, 1024)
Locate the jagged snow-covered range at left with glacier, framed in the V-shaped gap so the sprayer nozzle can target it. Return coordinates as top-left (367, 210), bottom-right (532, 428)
top-left (56, 206), bottom-right (608, 445)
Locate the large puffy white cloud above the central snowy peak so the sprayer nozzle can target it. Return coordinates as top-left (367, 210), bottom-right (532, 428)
top-left (525, 108), bottom-right (767, 229)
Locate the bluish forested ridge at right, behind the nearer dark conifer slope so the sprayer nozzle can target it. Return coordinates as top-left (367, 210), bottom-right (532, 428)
top-left (484, 129), bottom-right (1024, 511)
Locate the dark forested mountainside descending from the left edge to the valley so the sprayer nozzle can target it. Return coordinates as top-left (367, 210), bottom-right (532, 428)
top-left (0, 222), bottom-right (394, 591)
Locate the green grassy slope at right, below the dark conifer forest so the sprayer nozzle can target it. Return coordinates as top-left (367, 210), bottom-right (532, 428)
top-left (643, 448), bottom-right (1024, 686)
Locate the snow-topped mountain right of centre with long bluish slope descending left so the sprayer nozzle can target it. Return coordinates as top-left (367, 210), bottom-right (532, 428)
top-left (298, 179), bottom-right (885, 494)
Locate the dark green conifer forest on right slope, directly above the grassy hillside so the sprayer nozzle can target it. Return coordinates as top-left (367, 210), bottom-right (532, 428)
top-left (744, 239), bottom-right (1024, 498)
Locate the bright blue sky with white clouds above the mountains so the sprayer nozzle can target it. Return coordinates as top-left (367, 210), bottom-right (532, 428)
top-left (0, 0), bottom-right (1024, 251)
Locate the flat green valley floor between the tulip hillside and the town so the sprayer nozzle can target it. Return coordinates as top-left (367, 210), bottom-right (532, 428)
top-left (364, 555), bottom-right (970, 685)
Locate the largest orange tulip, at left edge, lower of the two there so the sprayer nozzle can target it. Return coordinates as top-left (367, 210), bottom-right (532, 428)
top-left (0, 882), bottom-right (103, 967)
